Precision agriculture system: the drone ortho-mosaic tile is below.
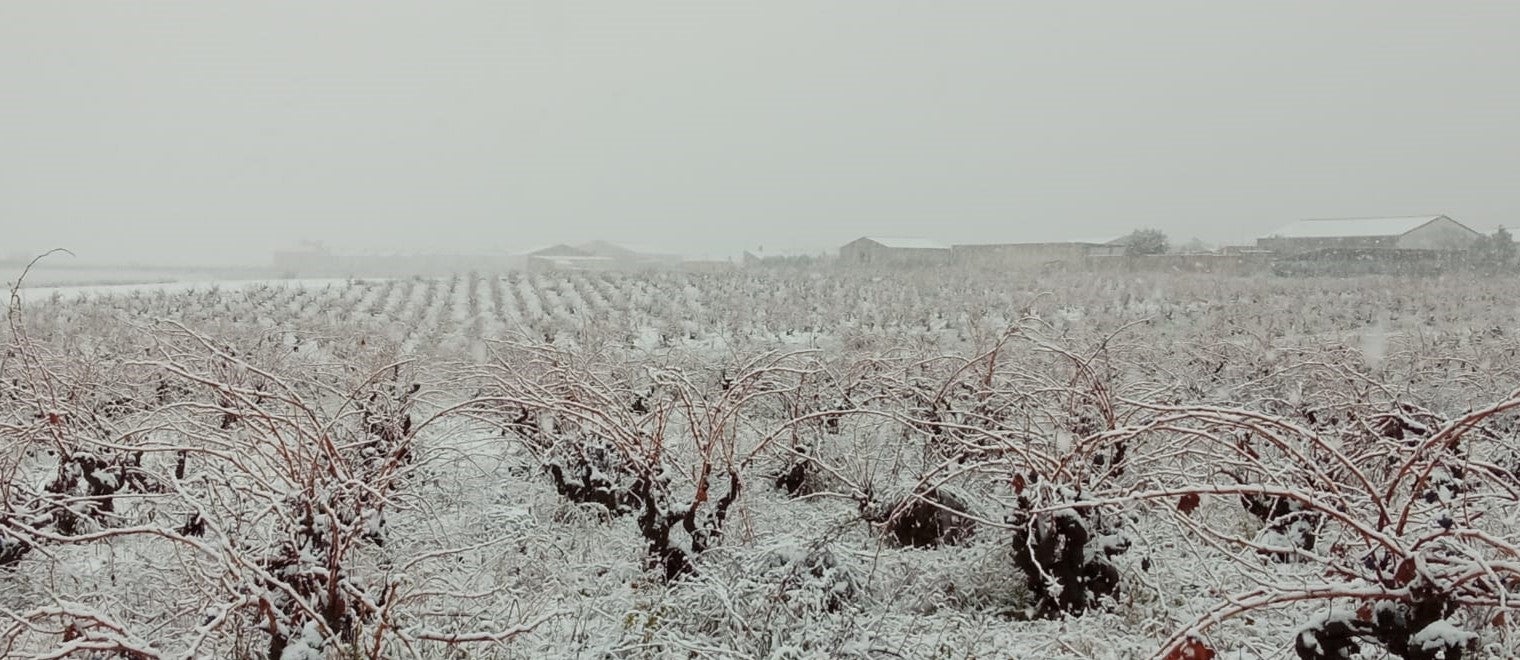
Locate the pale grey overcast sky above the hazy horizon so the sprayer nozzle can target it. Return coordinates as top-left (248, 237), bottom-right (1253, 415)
top-left (0, 0), bottom-right (1520, 263)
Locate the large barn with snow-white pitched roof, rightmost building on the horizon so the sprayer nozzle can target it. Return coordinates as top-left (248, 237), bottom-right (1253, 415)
top-left (1256, 216), bottom-right (1482, 254)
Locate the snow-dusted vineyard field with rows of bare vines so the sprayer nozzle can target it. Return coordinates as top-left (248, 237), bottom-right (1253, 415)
top-left (0, 271), bottom-right (1520, 660)
